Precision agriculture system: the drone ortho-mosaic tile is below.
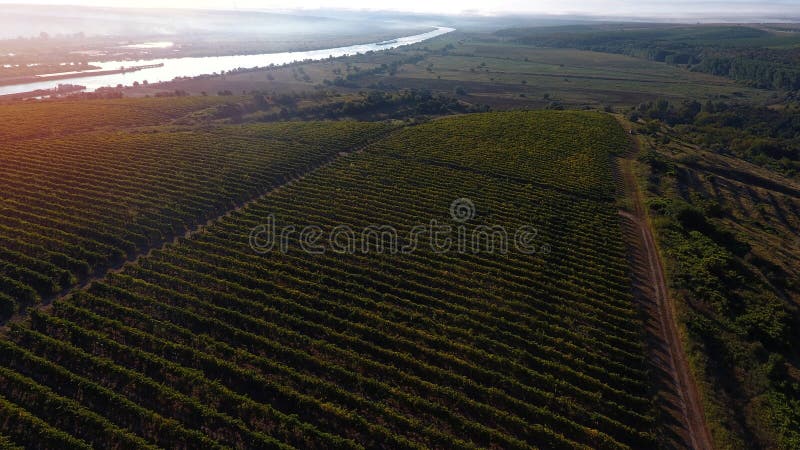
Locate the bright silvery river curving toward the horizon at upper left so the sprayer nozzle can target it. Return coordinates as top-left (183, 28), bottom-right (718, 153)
top-left (0, 27), bottom-right (455, 95)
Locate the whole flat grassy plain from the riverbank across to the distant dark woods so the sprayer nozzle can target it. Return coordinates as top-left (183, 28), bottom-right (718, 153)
top-left (123, 33), bottom-right (772, 109)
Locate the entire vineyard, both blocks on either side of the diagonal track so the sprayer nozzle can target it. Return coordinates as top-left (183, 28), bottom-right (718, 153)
top-left (0, 111), bottom-right (655, 449)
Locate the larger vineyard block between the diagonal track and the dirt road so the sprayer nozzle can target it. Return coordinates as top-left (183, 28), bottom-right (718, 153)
top-left (0, 112), bottom-right (654, 449)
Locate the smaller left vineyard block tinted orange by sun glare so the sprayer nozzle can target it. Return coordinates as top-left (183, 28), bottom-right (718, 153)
top-left (0, 118), bottom-right (388, 318)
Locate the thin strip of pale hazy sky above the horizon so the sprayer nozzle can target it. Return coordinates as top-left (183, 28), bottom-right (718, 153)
top-left (0, 0), bottom-right (800, 19)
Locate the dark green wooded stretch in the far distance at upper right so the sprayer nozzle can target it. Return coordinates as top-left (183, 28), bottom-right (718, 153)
top-left (496, 24), bottom-right (800, 91)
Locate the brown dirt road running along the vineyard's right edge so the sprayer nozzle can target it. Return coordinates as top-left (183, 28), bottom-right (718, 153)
top-left (617, 124), bottom-right (714, 450)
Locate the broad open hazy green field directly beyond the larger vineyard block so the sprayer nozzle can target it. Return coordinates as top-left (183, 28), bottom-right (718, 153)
top-left (390, 41), bottom-right (765, 107)
